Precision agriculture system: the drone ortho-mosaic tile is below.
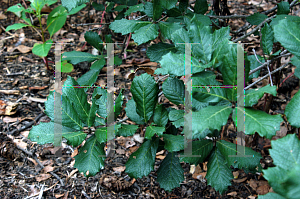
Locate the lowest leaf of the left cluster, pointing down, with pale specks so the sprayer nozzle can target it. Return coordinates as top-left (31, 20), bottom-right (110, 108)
top-left (74, 135), bottom-right (105, 177)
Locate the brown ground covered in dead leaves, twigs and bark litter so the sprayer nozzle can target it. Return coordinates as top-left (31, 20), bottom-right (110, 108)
top-left (0, 0), bottom-right (299, 199)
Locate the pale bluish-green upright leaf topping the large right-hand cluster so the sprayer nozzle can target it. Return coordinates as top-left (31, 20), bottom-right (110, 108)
top-left (189, 24), bottom-right (213, 64)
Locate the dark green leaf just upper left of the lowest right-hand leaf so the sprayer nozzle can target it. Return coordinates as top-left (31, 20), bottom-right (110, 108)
top-left (180, 140), bottom-right (214, 165)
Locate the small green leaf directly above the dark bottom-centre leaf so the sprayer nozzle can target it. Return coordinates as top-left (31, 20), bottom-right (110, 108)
top-left (163, 134), bottom-right (184, 152)
